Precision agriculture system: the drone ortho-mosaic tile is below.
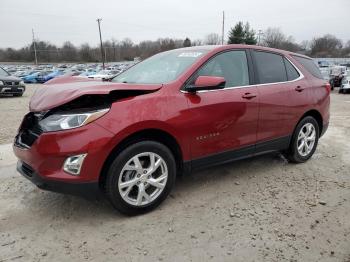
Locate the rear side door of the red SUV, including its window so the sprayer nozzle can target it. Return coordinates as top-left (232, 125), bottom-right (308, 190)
top-left (253, 51), bottom-right (308, 147)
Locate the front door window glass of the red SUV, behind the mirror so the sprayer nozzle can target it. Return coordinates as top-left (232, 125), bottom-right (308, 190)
top-left (194, 51), bottom-right (249, 87)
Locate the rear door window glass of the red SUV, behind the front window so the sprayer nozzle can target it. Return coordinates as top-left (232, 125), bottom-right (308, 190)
top-left (254, 51), bottom-right (287, 84)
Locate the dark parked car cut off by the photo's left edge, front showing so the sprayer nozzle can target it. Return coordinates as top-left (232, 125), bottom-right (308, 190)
top-left (0, 67), bottom-right (25, 96)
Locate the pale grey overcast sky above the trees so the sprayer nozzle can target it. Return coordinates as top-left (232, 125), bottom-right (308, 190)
top-left (0, 0), bottom-right (350, 48)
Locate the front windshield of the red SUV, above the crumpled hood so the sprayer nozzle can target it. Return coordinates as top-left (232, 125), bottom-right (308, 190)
top-left (112, 49), bottom-right (208, 84)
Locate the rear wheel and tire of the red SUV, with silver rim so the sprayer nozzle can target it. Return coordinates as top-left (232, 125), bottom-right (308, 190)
top-left (286, 116), bottom-right (320, 163)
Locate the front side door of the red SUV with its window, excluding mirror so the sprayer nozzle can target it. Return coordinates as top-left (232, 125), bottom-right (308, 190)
top-left (185, 50), bottom-right (258, 164)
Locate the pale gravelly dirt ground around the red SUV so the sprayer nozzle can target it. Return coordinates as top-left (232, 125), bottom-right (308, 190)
top-left (0, 86), bottom-right (350, 261)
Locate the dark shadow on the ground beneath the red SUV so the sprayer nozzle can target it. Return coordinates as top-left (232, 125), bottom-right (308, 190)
top-left (23, 153), bottom-right (287, 222)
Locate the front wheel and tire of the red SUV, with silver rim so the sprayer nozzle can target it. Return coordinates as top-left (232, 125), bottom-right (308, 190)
top-left (105, 141), bottom-right (176, 215)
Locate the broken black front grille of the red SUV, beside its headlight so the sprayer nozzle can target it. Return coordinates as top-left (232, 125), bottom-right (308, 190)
top-left (15, 112), bottom-right (44, 148)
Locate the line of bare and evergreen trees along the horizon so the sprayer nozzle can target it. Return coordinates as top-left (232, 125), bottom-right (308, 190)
top-left (0, 21), bottom-right (350, 63)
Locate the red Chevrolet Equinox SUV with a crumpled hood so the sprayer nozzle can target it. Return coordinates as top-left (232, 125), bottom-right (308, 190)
top-left (14, 45), bottom-right (330, 214)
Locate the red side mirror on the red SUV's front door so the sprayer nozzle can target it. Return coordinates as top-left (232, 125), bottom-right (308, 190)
top-left (186, 76), bottom-right (226, 93)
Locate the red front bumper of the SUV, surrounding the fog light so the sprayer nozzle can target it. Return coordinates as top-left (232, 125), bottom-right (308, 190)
top-left (13, 123), bottom-right (113, 196)
